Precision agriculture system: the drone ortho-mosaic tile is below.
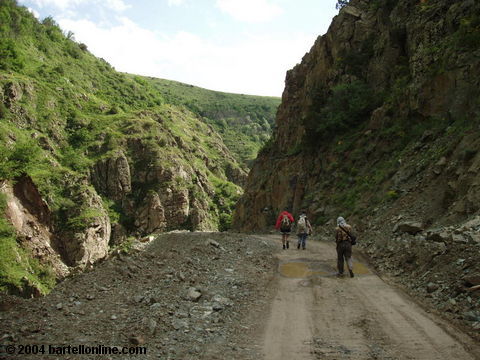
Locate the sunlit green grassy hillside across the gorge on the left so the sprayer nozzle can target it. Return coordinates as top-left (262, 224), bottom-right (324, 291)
top-left (0, 0), bottom-right (278, 292)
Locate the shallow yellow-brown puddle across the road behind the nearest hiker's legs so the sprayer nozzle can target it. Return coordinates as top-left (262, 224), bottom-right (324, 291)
top-left (279, 261), bottom-right (371, 279)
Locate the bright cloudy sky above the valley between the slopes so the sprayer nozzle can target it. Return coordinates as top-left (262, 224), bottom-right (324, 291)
top-left (18, 0), bottom-right (338, 96)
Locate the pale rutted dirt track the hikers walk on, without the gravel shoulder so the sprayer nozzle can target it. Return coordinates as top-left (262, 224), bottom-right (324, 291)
top-left (263, 239), bottom-right (480, 360)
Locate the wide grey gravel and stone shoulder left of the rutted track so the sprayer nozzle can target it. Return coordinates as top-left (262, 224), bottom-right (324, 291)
top-left (0, 233), bottom-right (275, 360)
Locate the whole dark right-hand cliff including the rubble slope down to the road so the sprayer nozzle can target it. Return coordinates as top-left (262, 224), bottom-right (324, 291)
top-left (234, 0), bottom-right (480, 330)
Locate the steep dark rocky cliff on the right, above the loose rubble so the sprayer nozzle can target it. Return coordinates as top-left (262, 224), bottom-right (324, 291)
top-left (235, 0), bottom-right (480, 230)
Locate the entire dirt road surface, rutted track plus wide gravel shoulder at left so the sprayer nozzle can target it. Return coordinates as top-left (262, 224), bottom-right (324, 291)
top-left (0, 233), bottom-right (480, 360)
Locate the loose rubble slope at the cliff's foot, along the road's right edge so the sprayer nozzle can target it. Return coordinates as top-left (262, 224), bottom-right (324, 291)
top-left (360, 216), bottom-right (480, 333)
